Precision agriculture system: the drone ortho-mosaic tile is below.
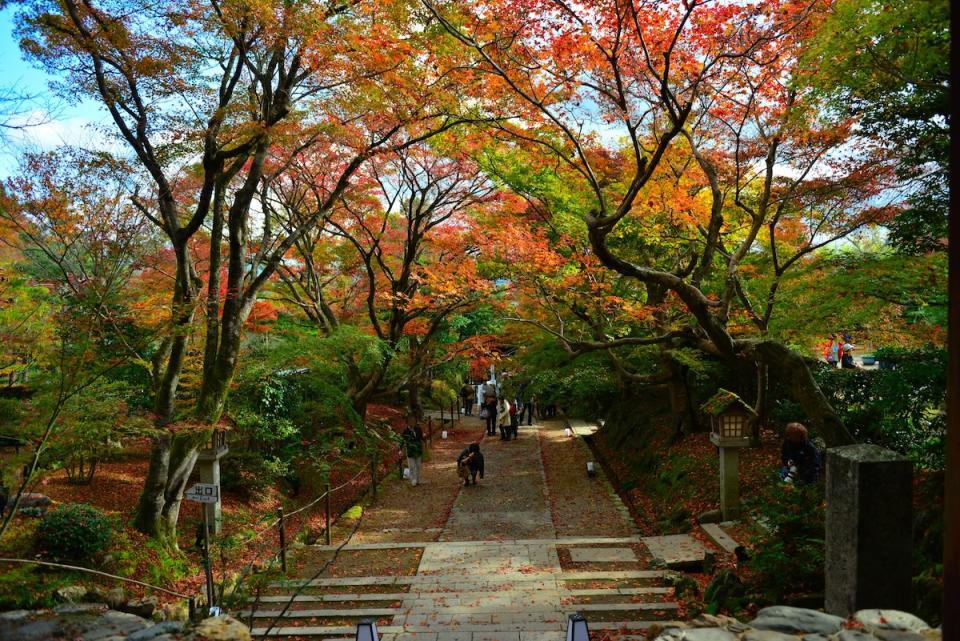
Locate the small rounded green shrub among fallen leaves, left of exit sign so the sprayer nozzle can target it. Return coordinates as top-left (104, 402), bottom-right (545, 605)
top-left (36, 503), bottom-right (113, 561)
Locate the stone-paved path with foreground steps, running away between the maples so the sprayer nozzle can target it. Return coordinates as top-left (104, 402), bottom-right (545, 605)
top-left (248, 419), bottom-right (696, 641)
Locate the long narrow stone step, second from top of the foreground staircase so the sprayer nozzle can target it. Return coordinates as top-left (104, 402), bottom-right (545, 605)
top-left (270, 570), bottom-right (666, 588)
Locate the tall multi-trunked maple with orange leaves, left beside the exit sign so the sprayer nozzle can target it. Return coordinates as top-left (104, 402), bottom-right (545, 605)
top-left (19, 0), bottom-right (492, 545)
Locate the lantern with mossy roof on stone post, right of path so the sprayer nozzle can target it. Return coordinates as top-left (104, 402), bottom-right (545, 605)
top-left (700, 389), bottom-right (757, 521)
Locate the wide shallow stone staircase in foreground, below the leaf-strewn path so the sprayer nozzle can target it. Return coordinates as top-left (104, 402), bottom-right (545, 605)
top-left (238, 537), bottom-right (692, 641)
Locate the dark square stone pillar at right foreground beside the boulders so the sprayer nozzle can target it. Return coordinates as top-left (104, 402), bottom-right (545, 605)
top-left (824, 444), bottom-right (913, 617)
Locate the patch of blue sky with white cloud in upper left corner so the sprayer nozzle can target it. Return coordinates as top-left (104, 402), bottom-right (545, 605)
top-left (0, 7), bottom-right (105, 178)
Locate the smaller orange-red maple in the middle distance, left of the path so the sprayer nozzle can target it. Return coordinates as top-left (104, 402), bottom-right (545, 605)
top-left (268, 141), bottom-right (492, 416)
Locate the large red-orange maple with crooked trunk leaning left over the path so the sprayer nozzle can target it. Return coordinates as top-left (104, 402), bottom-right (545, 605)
top-left (425, 2), bottom-right (916, 444)
